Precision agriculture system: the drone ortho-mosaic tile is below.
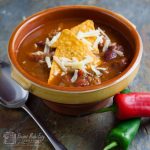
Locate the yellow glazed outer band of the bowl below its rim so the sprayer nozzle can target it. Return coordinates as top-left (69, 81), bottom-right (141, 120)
top-left (12, 65), bottom-right (139, 104)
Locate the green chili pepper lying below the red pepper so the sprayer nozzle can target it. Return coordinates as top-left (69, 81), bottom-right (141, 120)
top-left (104, 89), bottom-right (141, 150)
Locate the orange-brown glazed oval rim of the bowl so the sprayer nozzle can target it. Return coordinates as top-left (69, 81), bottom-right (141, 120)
top-left (8, 5), bottom-right (143, 93)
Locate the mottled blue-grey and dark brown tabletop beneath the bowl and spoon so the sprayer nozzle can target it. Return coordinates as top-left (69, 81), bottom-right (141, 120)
top-left (0, 0), bottom-right (150, 150)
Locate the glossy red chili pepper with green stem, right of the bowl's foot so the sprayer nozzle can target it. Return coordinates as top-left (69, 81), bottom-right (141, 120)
top-left (96, 92), bottom-right (150, 120)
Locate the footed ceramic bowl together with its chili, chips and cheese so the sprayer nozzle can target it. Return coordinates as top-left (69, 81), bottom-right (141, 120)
top-left (8, 5), bottom-right (143, 115)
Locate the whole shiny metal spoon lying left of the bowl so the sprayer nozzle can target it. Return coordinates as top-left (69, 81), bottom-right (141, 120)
top-left (0, 62), bottom-right (67, 150)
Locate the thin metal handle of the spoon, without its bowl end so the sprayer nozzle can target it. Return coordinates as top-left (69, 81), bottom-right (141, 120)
top-left (22, 105), bottom-right (67, 150)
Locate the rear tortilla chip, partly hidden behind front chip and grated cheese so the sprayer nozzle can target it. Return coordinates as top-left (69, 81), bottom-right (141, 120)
top-left (52, 20), bottom-right (99, 54)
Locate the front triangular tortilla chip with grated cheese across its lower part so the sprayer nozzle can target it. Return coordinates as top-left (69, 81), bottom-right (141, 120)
top-left (48, 29), bottom-right (100, 84)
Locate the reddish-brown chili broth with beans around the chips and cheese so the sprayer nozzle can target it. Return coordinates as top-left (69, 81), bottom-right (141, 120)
top-left (17, 19), bottom-right (132, 86)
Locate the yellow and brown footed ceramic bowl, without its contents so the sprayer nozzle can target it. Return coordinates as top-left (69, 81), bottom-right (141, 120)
top-left (8, 5), bottom-right (143, 115)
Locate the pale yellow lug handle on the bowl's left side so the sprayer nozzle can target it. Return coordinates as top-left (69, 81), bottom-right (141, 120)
top-left (11, 68), bottom-right (31, 91)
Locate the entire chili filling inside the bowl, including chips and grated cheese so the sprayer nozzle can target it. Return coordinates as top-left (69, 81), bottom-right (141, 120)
top-left (17, 19), bottom-right (132, 87)
